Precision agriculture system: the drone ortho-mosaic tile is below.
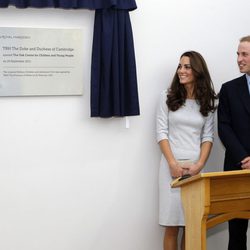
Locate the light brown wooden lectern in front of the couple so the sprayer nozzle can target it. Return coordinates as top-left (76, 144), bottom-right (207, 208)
top-left (172, 170), bottom-right (250, 250)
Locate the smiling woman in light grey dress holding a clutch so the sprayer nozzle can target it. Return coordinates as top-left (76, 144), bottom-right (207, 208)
top-left (157, 51), bottom-right (216, 250)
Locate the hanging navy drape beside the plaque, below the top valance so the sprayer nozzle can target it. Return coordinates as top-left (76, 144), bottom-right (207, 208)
top-left (91, 9), bottom-right (139, 117)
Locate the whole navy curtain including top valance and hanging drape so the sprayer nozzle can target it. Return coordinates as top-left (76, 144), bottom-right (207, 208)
top-left (0, 0), bottom-right (140, 117)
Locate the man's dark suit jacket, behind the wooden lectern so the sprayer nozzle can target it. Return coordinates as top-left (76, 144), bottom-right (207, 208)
top-left (218, 75), bottom-right (250, 170)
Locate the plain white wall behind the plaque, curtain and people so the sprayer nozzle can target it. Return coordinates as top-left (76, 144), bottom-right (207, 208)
top-left (0, 0), bottom-right (250, 250)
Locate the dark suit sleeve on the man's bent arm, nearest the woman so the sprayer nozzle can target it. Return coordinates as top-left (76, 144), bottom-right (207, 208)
top-left (218, 85), bottom-right (248, 164)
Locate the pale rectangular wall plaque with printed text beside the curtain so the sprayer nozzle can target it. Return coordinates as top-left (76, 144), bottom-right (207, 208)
top-left (0, 27), bottom-right (83, 96)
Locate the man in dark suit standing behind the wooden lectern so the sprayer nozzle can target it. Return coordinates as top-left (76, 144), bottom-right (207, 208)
top-left (218, 36), bottom-right (250, 250)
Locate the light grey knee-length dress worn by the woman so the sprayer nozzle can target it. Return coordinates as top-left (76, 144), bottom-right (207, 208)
top-left (156, 91), bottom-right (214, 226)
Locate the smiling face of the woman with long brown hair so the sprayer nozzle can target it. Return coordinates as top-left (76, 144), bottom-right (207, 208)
top-left (177, 56), bottom-right (195, 85)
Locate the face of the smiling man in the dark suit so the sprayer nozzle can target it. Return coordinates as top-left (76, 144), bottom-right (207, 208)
top-left (237, 42), bottom-right (250, 75)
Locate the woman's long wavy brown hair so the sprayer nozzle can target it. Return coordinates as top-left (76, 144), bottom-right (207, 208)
top-left (166, 51), bottom-right (217, 116)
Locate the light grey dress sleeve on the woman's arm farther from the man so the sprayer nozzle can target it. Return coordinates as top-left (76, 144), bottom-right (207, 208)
top-left (156, 90), bottom-right (168, 142)
